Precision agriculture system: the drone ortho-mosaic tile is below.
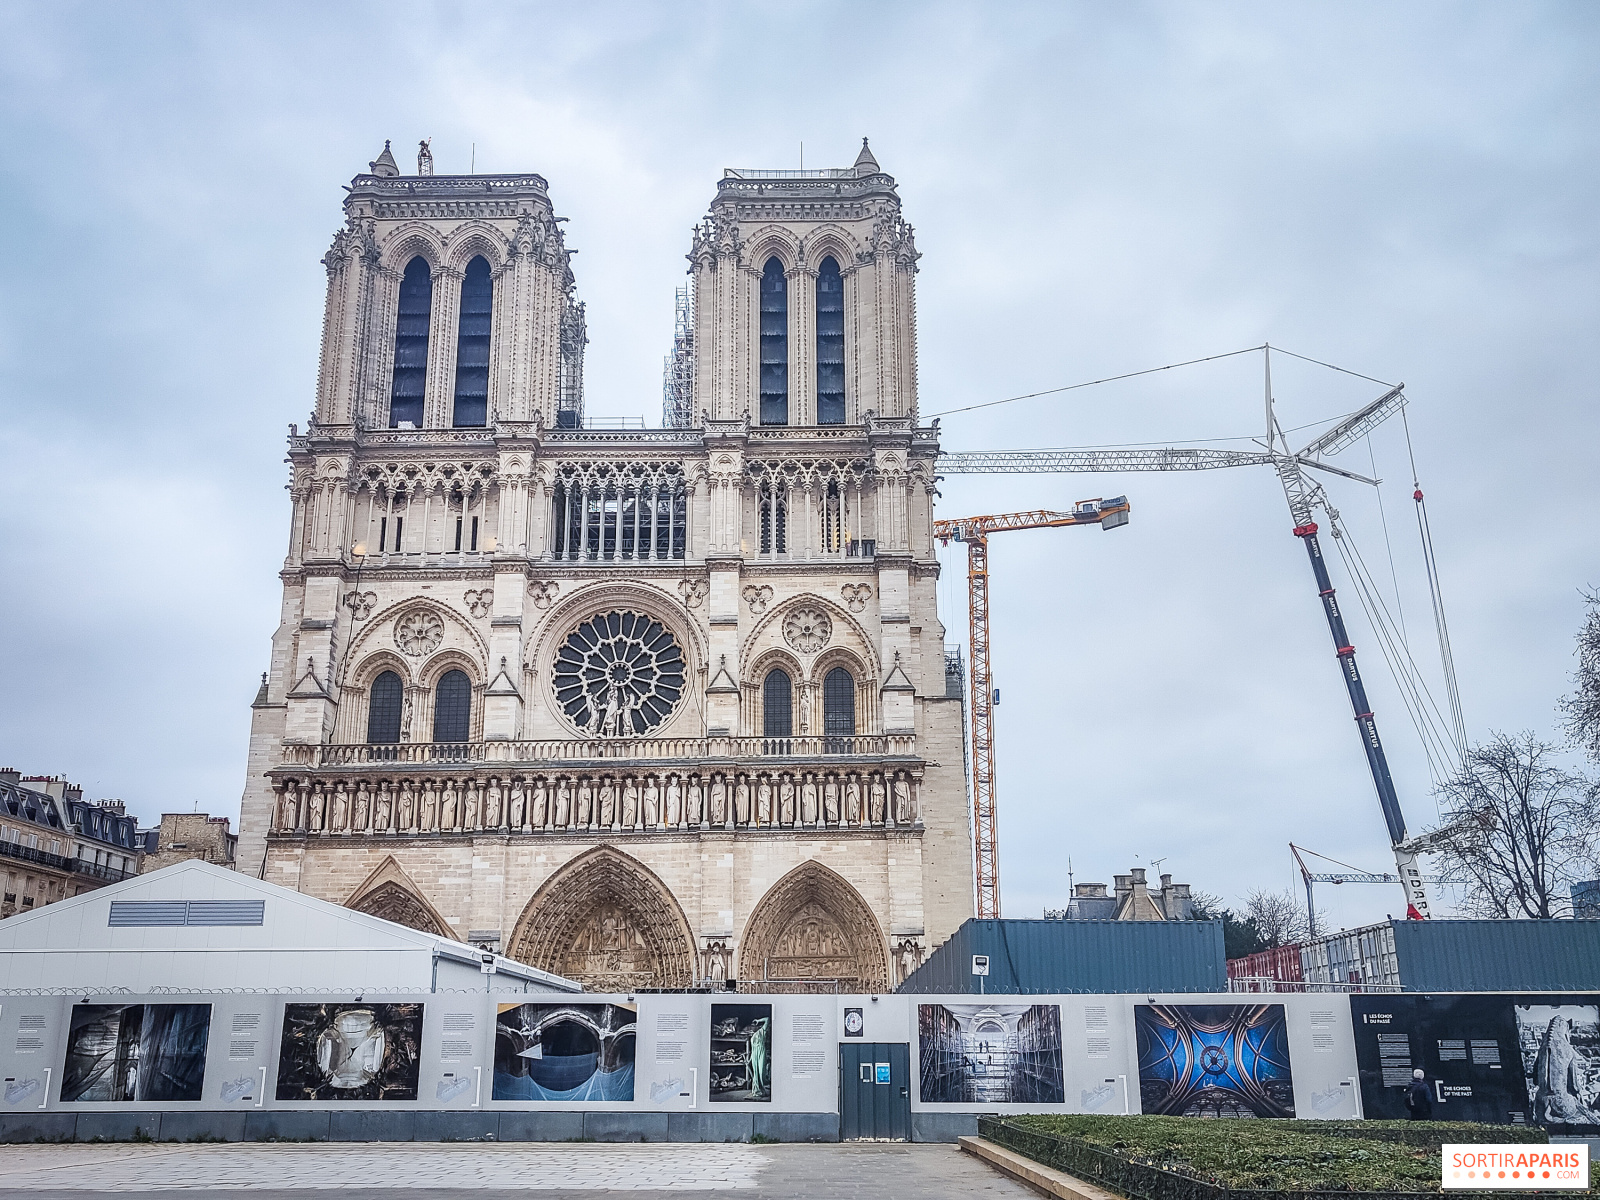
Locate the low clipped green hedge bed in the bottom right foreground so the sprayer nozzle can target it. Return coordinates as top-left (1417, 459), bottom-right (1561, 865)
top-left (978, 1115), bottom-right (1574, 1200)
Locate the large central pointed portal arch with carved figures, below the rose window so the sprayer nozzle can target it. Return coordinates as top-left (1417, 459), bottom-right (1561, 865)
top-left (509, 846), bottom-right (696, 992)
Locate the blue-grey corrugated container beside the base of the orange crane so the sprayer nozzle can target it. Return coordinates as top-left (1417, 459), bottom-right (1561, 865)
top-left (896, 917), bottom-right (1227, 995)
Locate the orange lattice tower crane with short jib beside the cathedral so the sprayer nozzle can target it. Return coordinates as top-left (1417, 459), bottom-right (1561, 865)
top-left (933, 496), bottom-right (1128, 917)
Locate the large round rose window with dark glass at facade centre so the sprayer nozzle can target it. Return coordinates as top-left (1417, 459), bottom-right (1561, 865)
top-left (555, 611), bottom-right (685, 738)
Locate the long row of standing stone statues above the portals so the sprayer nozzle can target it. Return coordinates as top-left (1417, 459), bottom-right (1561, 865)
top-left (270, 764), bottom-right (920, 837)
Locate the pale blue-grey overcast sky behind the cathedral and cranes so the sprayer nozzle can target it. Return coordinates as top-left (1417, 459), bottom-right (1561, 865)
top-left (0, 0), bottom-right (1600, 923)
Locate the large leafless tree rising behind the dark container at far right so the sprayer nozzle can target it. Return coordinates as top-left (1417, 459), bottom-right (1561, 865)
top-left (1430, 733), bottom-right (1600, 917)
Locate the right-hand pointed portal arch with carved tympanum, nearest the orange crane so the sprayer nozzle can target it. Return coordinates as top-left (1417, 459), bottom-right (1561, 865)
top-left (739, 861), bottom-right (890, 992)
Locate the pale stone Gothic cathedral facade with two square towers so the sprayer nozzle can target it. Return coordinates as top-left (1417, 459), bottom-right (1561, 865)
top-left (240, 136), bottom-right (973, 990)
